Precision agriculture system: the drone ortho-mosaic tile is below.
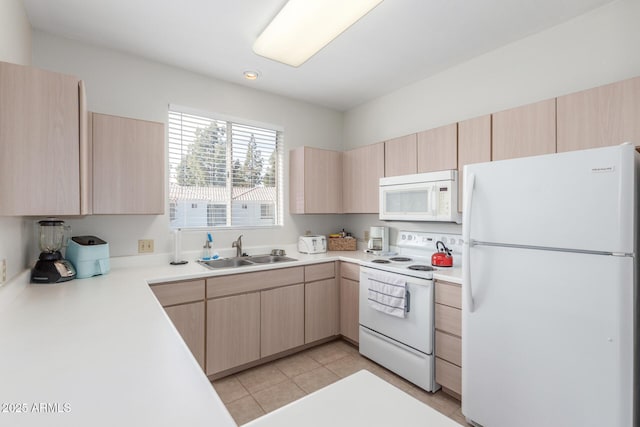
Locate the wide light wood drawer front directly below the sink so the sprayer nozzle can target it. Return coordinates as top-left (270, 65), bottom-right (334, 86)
top-left (207, 267), bottom-right (304, 298)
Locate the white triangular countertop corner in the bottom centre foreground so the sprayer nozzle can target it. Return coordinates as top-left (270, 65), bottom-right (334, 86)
top-left (245, 370), bottom-right (460, 427)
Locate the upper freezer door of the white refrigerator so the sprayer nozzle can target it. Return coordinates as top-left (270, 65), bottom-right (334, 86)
top-left (463, 144), bottom-right (640, 253)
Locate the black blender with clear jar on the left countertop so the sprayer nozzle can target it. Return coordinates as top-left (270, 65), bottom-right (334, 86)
top-left (31, 218), bottom-right (76, 283)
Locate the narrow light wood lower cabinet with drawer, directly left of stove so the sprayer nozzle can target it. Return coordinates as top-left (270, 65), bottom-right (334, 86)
top-left (340, 262), bottom-right (360, 344)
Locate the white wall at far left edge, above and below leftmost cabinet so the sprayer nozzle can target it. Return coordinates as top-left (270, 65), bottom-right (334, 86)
top-left (0, 0), bottom-right (32, 279)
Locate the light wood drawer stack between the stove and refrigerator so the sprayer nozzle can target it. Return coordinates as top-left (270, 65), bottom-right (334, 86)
top-left (435, 280), bottom-right (462, 399)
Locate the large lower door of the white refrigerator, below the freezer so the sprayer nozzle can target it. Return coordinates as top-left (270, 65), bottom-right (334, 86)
top-left (462, 246), bottom-right (637, 427)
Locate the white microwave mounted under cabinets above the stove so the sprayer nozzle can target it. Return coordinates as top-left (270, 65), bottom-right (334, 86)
top-left (380, 170), bottom-right (461, 224)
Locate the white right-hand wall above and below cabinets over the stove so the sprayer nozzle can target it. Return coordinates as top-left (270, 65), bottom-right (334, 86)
top-left (343, 0), bottom-right (640, 241)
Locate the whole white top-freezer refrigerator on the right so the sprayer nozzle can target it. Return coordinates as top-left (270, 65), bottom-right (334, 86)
top-left (462, 144), bottom-right (640, 427)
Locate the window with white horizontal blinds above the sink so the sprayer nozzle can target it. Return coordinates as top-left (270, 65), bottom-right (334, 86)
top-left (169, 106), bottom-right (283, 228)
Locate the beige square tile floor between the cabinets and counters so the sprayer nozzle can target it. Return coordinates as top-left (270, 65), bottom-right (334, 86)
top-left (212, 340), bottom-right (469, 426)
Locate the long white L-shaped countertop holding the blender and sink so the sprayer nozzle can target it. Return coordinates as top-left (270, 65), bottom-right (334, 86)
top-left (0, 251), bottom-right (456, 426)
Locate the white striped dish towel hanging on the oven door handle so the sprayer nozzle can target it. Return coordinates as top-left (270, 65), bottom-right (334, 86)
top-left (367, 272), bottom-right (407, 318)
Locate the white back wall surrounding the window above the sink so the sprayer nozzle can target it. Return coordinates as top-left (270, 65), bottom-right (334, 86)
top-left (33, 31), bottom-right (343, 256)
